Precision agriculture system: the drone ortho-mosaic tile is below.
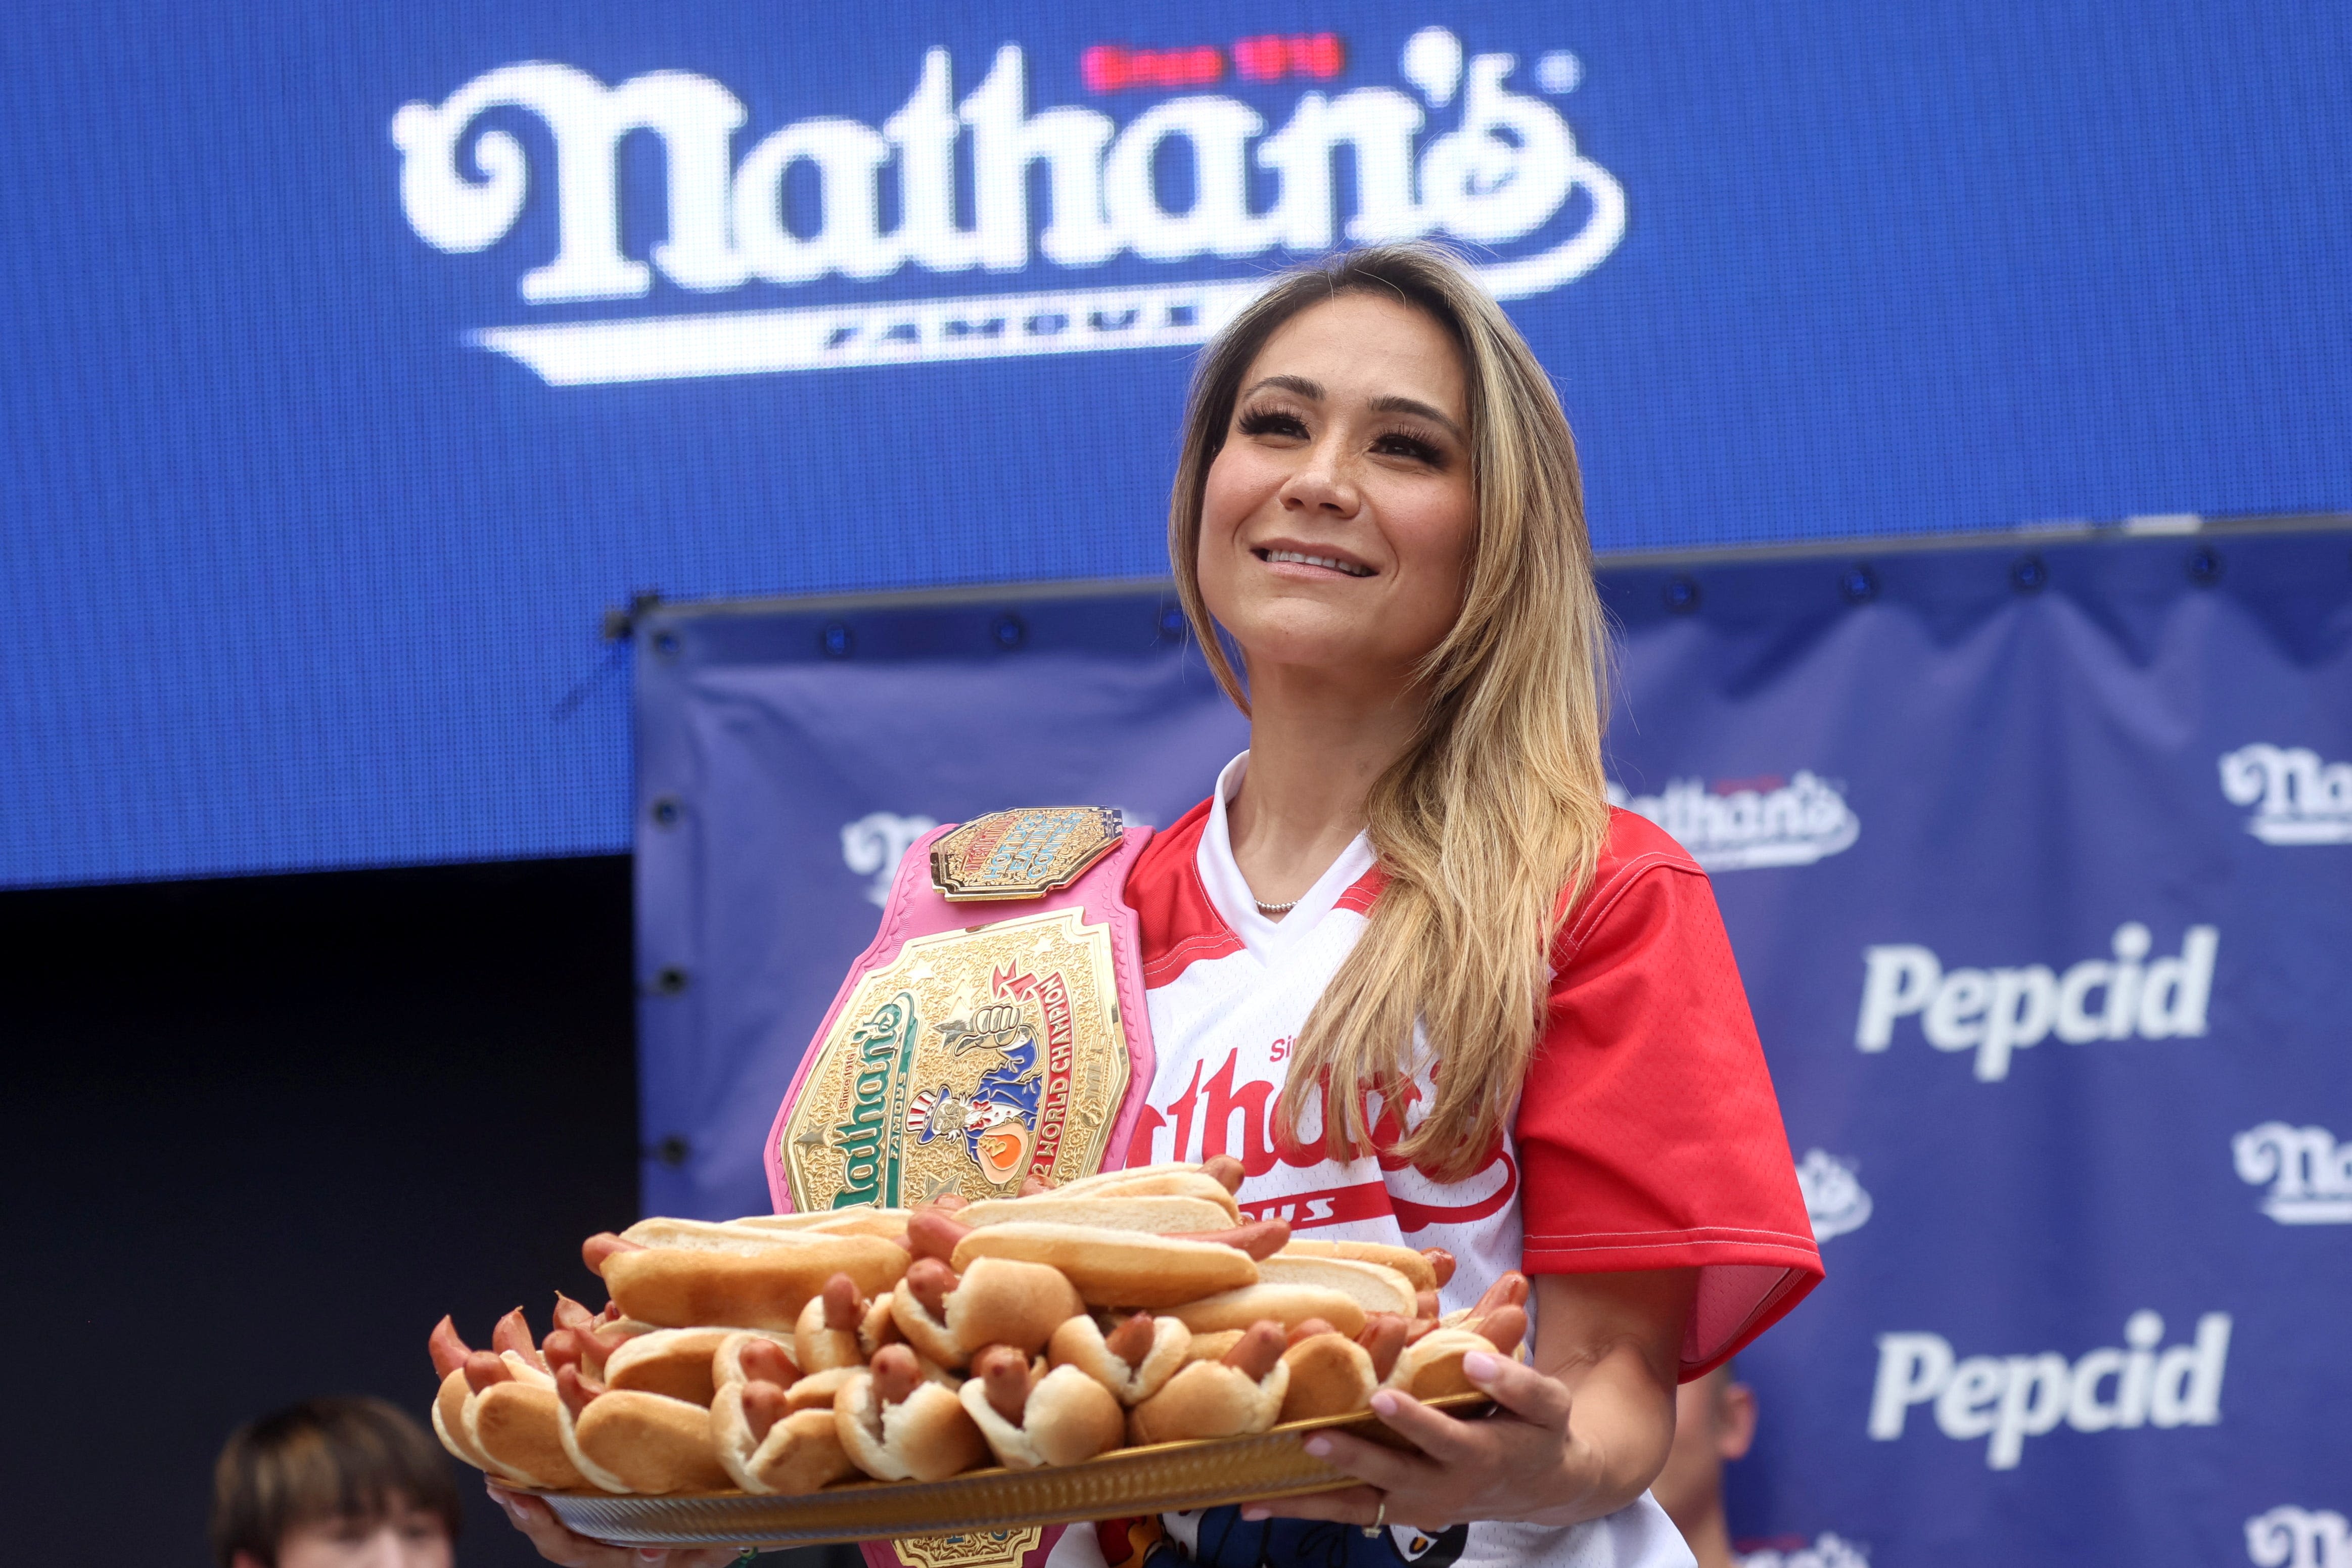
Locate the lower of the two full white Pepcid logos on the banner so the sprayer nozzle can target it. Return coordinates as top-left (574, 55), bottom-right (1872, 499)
top-left (1870, 1312), bottom-right (2230, 1469)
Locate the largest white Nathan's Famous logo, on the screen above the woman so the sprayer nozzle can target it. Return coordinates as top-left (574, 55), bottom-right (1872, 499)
top-left (390, 26), bottom-right (1625, 386)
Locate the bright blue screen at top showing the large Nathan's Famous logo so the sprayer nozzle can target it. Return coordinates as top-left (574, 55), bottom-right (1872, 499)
top-left (0, 0), bottom-right (2352, 884)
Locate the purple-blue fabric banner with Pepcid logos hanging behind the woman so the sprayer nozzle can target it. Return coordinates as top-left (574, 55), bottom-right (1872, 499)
top-left (637, 529), bottom-right (2352, 1568)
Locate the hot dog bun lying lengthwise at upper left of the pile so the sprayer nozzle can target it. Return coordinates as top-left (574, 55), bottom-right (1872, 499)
top-left (605, 1227), bottom-right (908, 1330)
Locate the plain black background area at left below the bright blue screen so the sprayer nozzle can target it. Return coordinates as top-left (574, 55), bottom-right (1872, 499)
top-left (0, 856), bottom-right (856, 1568)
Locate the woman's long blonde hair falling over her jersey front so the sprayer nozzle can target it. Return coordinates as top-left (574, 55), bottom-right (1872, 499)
top-left (1169, 245), bottom-right (1609, 1178)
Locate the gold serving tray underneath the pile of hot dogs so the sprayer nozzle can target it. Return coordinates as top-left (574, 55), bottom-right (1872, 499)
top-left (539, 1394), bottom-right (1489, 1547)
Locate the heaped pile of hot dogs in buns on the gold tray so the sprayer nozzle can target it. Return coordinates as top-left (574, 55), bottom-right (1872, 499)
top-left (430, 1161), bottom-right (1527, 1493)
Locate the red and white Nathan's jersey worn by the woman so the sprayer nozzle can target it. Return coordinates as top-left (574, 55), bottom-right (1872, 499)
top-left (1051, 752), bottom-right (1820, 1568)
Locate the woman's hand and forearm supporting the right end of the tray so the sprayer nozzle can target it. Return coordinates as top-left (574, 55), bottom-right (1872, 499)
top-left (1242, 1269), bottom-right (1696, 1531)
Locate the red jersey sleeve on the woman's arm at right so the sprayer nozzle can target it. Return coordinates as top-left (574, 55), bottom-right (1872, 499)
top-left (1515, 811), bottom-right (1820, 1380)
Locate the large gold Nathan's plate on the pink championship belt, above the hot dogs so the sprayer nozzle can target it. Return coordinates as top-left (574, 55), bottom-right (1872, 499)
top-left (776, 910), bottom-right (1127, 1211)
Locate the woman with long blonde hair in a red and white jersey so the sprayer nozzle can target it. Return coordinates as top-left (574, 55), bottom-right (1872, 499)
top-left (491, 247), bottom-right (1820, 1568)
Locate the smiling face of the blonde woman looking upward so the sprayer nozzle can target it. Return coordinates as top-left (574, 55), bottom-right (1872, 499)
top-left (1200, 294), bottom-right (1477, 686)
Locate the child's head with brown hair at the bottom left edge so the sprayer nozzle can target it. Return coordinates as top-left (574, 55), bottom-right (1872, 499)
top-left (212, 1397), bottom-right (458, 1568)
